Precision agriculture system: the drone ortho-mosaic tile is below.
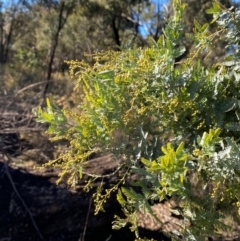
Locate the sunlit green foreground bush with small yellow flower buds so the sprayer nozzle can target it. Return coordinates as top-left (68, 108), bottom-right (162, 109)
top-left (35, 0), bottom-right (240, 240)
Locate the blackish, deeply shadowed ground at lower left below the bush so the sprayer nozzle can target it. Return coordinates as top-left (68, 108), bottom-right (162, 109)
top-left (0, 152), bottom-right (172, 241)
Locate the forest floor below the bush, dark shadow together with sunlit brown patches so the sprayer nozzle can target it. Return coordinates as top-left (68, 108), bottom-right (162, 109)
top-left (0, 135), bottom-right (240, 241)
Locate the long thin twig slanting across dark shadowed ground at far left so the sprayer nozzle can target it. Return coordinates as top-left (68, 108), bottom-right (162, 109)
top-left (3, 155), bottom-right (45, 241)
